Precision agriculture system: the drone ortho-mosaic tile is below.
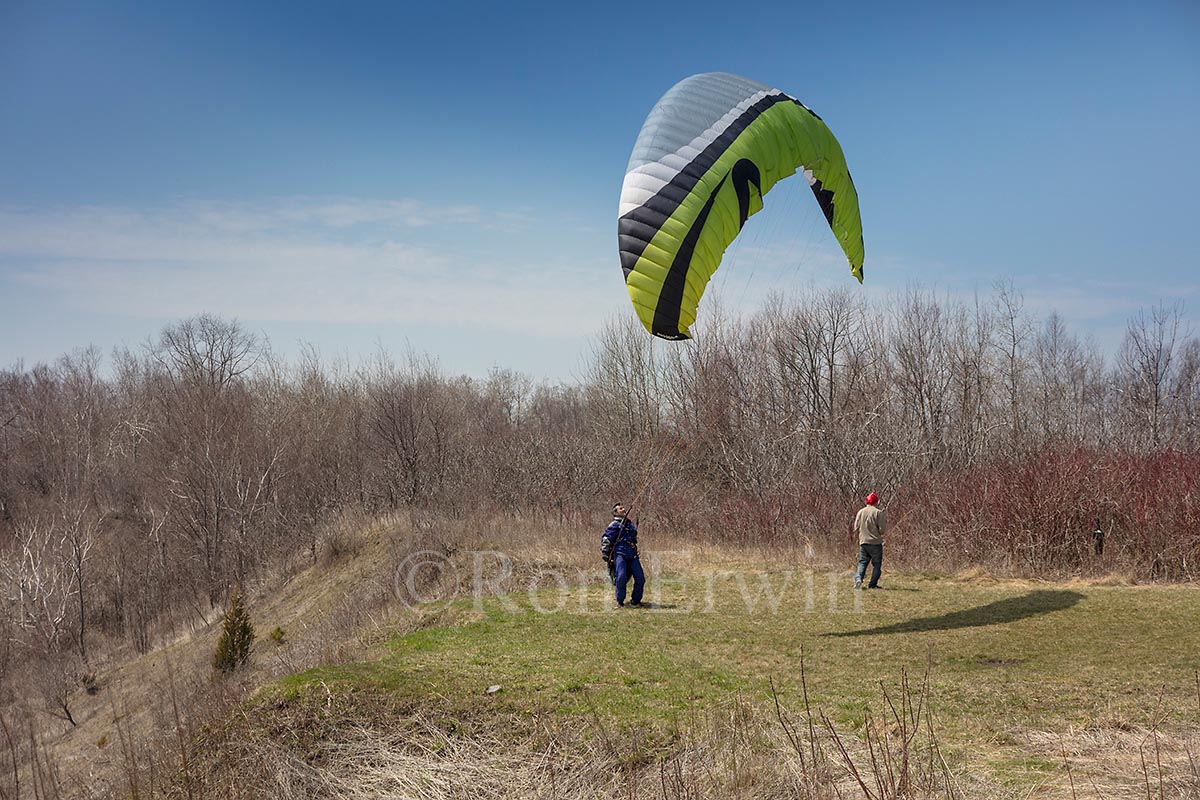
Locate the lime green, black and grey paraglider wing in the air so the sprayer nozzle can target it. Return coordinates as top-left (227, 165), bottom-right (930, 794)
top-left (617, 72), bottom-right (863, 339)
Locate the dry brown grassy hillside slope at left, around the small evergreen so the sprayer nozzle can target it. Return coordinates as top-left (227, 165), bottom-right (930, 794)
top-left (0, 510), bottom-right (432, 799)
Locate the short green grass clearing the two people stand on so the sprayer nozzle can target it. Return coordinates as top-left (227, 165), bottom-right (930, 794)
top-left (274, 569), bottom-right (1200, 796)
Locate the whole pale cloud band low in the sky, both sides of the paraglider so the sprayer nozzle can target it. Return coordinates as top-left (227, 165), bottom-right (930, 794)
top-left (0, 197), bottom-right (1198, 376)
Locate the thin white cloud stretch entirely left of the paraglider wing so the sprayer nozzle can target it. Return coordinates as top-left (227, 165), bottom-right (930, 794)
top-left (0, 198), bottom-right (611, 335)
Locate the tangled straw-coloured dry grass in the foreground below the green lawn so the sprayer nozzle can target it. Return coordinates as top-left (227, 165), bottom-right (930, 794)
top-left (169, 682), bottom-right (1016, 800)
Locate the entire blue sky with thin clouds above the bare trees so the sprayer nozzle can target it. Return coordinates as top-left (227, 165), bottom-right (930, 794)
top-left (0, 0), bottom-right (1200, 379)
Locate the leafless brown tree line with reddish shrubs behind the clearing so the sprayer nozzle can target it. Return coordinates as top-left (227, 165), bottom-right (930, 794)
top-left (0, 284), bottom-right (1200, 695)
